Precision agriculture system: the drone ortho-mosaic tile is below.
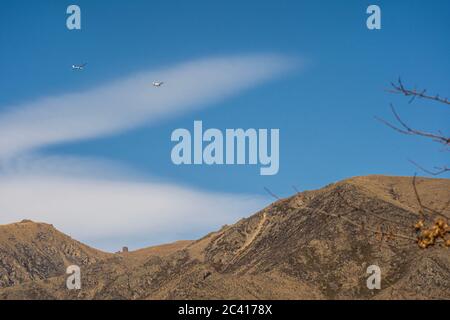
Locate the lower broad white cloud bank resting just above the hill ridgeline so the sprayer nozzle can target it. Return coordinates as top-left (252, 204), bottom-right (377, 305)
top-left (0, 156), bottom-right (267, 251)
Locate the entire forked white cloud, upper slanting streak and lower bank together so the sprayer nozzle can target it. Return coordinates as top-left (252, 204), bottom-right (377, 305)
top-left (0, 55), bottom-right (294, 250)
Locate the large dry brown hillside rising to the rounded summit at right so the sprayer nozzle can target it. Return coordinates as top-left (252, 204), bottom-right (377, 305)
top-left (0, 176), bottom-right (450, 299)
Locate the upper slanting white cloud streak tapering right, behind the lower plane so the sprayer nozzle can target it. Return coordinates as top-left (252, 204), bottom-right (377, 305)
top-left (0, 55), bottom-right (294, 158)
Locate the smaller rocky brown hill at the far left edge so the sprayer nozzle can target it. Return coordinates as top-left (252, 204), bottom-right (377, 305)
top-left (0, 220), bottom-right (109, 287)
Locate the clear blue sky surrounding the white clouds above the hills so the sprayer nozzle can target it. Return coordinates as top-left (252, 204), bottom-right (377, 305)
top-left (0, 0), bottom-right (450, 247)
